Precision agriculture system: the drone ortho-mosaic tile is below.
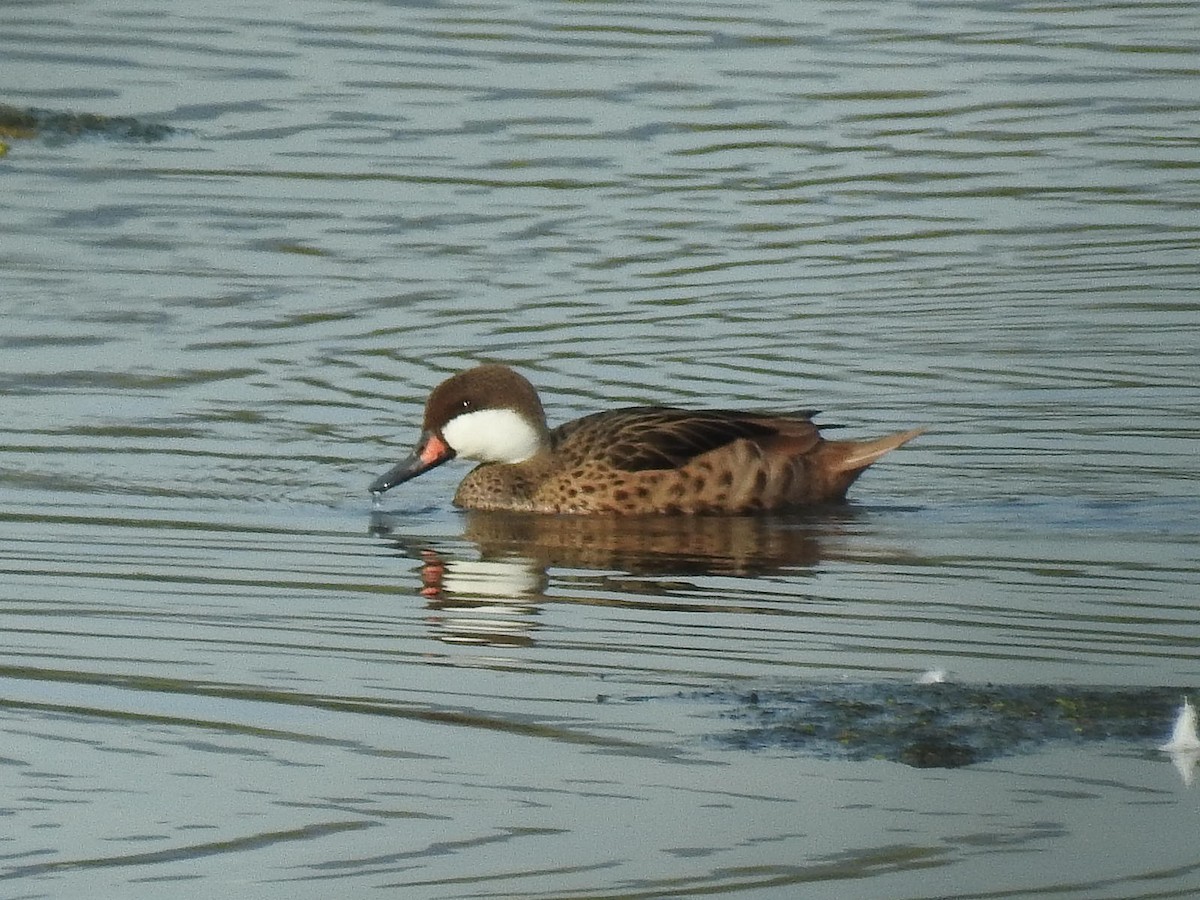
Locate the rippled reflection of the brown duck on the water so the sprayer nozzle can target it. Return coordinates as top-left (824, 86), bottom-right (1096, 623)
top-left (371, 508), bottom-right (840, 646)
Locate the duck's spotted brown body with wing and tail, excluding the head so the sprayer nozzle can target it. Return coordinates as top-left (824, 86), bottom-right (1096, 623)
top-left (455, 407), bottom-right (917, 515)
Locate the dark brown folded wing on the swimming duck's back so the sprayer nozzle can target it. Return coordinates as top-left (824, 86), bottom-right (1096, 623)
top-left (551, 407), bottom-right (820, 472)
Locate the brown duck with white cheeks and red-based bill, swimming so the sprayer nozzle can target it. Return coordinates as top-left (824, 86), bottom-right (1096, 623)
top-left (370, 364), bottom-right (923, 515)
